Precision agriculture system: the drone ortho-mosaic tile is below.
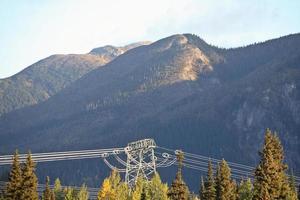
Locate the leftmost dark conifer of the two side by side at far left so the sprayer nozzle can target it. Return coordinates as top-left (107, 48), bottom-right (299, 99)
top-left (5, 150), bottom-right (23, 200)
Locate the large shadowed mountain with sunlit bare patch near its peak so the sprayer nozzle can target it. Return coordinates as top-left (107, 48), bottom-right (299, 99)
top-left (0, 34), bottom-right (300, 188)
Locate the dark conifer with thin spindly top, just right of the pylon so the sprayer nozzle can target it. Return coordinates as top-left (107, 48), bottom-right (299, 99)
top-left (168, 151), bottom-right (189, 200)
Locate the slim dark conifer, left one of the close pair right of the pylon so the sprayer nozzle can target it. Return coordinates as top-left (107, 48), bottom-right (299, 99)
top-left (202, 161), bottom-right (216, 200)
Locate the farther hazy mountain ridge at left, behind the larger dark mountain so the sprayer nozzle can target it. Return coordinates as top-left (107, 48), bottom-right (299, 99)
top-left (0, 42), bottom-right (149, 116)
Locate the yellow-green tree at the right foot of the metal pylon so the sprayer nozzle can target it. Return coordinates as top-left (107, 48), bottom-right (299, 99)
top-left (147, 173), bottom-right (168, 200)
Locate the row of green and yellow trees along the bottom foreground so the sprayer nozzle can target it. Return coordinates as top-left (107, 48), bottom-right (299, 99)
top-left (0, 129), bottom-right (300, 200)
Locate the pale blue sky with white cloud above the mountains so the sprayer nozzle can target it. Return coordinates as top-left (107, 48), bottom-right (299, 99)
top-left (0, 0), bottom-right (300, 78)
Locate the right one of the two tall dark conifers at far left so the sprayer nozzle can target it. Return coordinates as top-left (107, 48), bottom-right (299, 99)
top-left (20, 152), bottom-right (39, 200)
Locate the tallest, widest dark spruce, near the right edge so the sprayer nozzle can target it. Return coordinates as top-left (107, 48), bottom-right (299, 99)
top-left (253, 129), bottom-right (296, 200)
